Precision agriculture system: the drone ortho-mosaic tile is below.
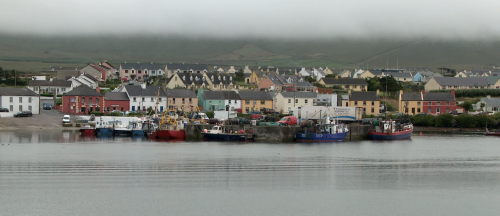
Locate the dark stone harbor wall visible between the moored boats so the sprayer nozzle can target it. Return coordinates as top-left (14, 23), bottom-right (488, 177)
top-left (185, 124), bottom-right (370, 142)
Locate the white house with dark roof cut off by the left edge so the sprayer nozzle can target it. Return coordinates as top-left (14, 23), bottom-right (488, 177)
top-left (0, 87), bottom-right (40, 118)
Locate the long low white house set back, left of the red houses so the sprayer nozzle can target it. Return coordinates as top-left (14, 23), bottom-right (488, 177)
top-left (27, 80), bottom-right (75, 94)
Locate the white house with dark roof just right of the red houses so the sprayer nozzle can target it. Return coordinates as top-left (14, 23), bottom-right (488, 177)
top-left (121, 83), bottom-right (167, 112)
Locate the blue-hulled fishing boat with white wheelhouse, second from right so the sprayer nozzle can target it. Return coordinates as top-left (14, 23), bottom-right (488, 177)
top-left (295, 117), bottom-right (349, 142)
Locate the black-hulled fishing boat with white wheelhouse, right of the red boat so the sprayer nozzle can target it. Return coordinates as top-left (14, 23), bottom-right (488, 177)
top-left (201, 125), bottom-right (254, 142)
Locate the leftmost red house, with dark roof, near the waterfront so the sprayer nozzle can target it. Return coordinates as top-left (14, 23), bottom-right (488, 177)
top-left (61, 85), bottom-right (104, 115)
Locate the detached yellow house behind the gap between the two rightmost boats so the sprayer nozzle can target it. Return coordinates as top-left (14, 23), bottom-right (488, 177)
top-left (349, 90), bottom-right (380, 115)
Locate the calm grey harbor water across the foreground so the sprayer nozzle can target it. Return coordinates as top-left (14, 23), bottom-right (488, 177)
top-left (0, 131), bottom-right (500, 215)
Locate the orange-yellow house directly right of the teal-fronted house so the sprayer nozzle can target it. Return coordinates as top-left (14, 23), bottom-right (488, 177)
top-left (240, 91), bottom-right (273, 113)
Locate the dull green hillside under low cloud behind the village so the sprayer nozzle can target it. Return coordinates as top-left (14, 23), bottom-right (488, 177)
top-left (0, 35), bottom-right (500, 71)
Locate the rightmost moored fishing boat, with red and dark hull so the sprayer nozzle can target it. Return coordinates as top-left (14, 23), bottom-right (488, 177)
top-left (368, 120), bottom-right (413, 140)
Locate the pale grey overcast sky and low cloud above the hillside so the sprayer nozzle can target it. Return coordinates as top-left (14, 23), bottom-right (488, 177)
top-left (0, 0), bottom-right (500, 39)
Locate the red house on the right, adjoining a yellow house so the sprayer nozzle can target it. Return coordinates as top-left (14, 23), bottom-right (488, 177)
top-left (422, 90), bottom-right (463, 115)
